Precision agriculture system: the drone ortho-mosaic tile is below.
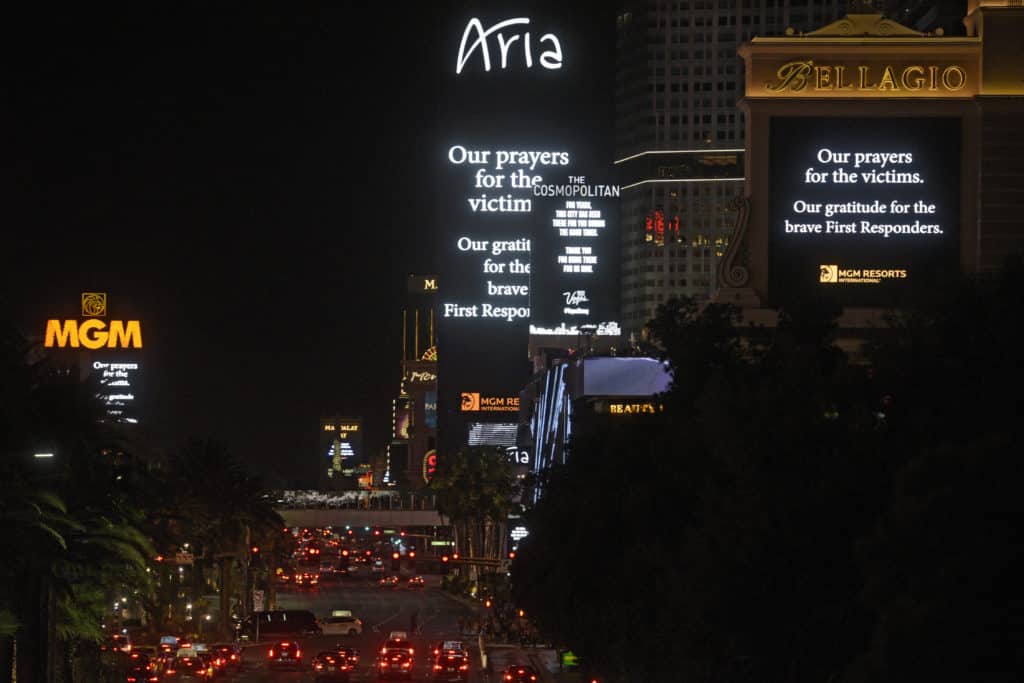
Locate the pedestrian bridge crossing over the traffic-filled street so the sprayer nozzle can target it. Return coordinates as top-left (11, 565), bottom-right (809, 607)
top-left (267, 490), bottom-right (447, 528)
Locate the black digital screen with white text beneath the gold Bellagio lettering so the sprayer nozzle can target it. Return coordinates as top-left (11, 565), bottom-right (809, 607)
top-left (769, 117), bottom-right (961, 306)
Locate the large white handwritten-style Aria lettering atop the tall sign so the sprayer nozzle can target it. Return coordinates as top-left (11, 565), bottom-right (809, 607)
top-left (455, 16), bottom-right (562, 75)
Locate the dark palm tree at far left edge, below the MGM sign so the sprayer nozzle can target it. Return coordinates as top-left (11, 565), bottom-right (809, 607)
top-left (0, 325), bottom-right (155, 683)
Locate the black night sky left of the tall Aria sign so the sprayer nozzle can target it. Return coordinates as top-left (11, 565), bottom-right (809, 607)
top-left (0, 2), bottom-right (614, 483)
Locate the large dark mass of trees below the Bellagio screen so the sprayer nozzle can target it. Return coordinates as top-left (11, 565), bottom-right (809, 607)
top-left (512, 262), bottom-right (1024, 682)
